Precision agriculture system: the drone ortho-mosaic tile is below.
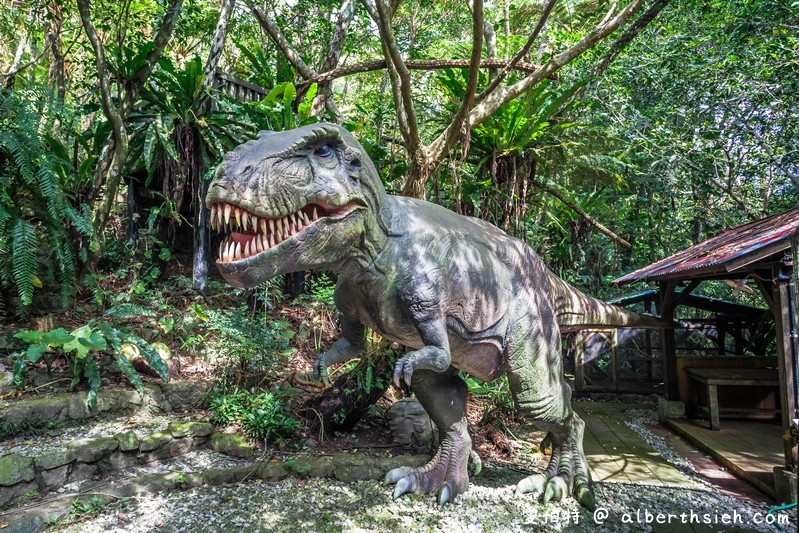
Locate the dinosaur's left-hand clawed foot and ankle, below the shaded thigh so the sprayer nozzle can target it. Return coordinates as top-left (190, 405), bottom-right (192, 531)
top-left (384, 419), bottom-right (472, 506)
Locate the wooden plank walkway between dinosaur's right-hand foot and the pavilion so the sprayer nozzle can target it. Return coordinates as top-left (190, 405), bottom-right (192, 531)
top-left (574, 402), bottom-right (697, 488)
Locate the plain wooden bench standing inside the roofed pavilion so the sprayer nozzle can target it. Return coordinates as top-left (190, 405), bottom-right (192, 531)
top-left (685, 368), bottom-right (780, 431)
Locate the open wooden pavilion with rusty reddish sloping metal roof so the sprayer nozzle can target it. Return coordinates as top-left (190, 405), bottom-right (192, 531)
top-left (614, 207), bottom-right (799, 496)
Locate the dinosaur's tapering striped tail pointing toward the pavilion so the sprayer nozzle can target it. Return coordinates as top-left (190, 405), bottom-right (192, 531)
top-left (549, 273), bottom-right (675, 333)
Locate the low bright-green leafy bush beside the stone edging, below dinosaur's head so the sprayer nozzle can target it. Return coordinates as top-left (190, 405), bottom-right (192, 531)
top-left (211, 390), bottom-right (299, 442)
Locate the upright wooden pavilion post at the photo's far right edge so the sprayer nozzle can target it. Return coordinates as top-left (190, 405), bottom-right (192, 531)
top-left (771, 264), bottom-right (799, 469)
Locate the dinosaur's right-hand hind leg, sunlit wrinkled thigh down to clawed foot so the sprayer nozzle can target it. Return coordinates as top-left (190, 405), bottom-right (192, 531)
top-left (508, 322), bottom-right (596, 509)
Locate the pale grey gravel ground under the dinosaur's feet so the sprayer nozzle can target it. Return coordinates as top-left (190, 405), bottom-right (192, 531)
top-left (65, 410), bottom-right (796, 532)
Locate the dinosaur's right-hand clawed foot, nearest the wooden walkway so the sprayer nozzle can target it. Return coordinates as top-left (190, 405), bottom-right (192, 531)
top-left (516, 428), bottom-right (596, 510)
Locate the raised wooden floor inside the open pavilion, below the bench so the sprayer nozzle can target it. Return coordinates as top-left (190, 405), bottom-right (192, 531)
top-left (666, 419), bottom-right (784, 498)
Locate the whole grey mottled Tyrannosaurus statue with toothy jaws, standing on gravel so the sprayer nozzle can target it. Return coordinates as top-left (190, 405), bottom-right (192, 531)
top-left (207, 124), bottom-right (660, 507)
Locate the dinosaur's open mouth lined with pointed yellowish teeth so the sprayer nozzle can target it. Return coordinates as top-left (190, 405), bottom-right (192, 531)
top-left (210, 202), bottom-right (360, 263)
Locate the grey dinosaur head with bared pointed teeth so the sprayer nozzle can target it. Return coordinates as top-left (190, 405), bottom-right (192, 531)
top-left (206, 124), bottom-right (386, 287)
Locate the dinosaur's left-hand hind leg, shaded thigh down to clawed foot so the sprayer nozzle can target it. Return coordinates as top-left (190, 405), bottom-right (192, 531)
top-left (385, 368), bottom-right (472, 505)
